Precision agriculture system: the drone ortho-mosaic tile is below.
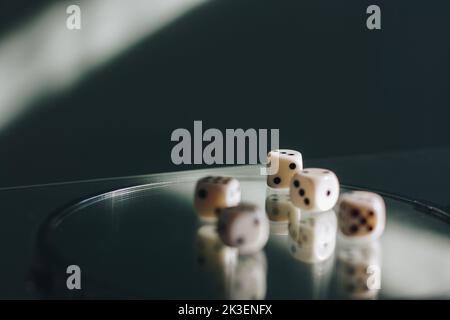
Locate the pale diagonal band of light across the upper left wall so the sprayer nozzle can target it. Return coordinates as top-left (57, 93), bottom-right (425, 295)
top-left (0, 0), bottom-right (207, 130)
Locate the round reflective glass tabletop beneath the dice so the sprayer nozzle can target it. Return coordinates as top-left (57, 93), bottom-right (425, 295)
top-left (34, 174), bottom-right (450, 299)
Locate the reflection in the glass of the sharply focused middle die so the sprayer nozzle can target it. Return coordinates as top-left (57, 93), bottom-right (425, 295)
top-left (289, 210), bottom-right (337, 263)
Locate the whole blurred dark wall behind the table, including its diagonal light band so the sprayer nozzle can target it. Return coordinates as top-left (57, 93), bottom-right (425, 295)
top-left (0, 0), bottom-right (450, 186)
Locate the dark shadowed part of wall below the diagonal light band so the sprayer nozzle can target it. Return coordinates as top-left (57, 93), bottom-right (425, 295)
top-left (0, 0), bottom-right (449, 186)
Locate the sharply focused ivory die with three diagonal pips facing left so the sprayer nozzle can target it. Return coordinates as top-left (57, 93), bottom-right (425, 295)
top-left (290, 168), bottom-right (339, 212)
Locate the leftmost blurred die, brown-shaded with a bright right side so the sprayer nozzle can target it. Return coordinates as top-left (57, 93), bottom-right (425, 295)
top-left (194, 176), bottom-right (241, 221)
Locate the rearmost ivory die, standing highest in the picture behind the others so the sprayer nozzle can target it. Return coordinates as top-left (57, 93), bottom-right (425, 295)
top-left (267, 149), bottom-right (303, 188)
